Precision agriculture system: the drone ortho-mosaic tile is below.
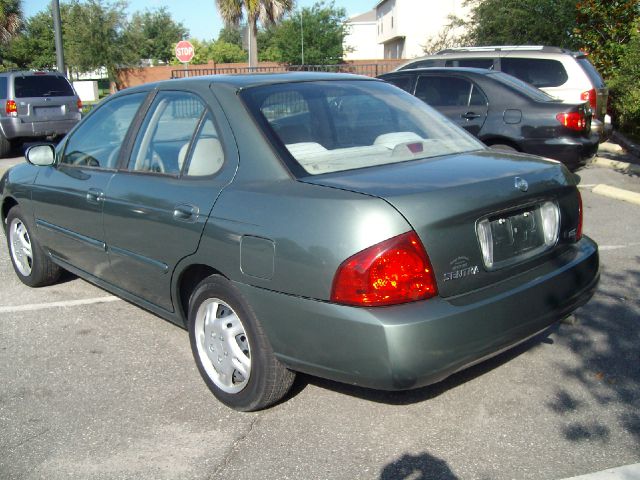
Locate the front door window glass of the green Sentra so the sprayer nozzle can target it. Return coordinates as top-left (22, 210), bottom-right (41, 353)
top-left (60, 92), bottom-right (147, 168)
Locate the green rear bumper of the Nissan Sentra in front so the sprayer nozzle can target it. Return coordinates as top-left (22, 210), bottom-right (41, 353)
top-left (237, 237), bottom-right (599, 390)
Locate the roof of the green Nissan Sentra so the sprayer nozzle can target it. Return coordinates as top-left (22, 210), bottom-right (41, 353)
top-left (127, 72), bottom-right (376, 92)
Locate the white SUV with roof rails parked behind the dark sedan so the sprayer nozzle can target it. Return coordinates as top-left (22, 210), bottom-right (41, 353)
top-left (398, 45), bottom-right (612, 141)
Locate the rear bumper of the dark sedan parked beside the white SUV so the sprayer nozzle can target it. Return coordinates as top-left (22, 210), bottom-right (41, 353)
top-left (522, 132), bottom-right (600, 167)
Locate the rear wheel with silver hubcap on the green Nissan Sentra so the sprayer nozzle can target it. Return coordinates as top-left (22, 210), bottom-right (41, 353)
top-left (188, 275), bottom-right (295, 412)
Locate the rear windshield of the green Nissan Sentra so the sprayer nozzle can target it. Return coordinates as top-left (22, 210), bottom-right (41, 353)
top-left (242, 80), bottom-right (484, 176)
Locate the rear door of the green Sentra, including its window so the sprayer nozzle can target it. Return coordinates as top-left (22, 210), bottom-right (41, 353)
top-left (104, 91), bottom-right (237, 311)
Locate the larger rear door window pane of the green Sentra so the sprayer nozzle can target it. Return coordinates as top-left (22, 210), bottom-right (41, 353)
top-left (129, 92), bottom-right (205, 175)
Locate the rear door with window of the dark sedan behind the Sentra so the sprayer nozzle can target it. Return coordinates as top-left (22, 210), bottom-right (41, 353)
top-left (414, 75), bottom-right (488, 136)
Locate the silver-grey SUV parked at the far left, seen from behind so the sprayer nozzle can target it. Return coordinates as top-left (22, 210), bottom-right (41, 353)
top-left (0, 71), bottom-right (82, 158)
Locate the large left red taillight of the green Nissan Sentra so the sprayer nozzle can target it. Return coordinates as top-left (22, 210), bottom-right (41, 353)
top-left (331, 231), bottom-right (438, 306)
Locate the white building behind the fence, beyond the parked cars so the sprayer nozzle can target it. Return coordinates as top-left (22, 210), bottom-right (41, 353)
top-left (345, 0), bottom-right (469, 60)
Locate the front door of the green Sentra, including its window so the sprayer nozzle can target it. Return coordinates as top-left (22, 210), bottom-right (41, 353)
top-left (33, 93), bottom-right (146, 276)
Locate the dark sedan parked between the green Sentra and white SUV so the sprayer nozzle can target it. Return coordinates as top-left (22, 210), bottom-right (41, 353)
top-left (379, 68), bottom-right (600, 168)
